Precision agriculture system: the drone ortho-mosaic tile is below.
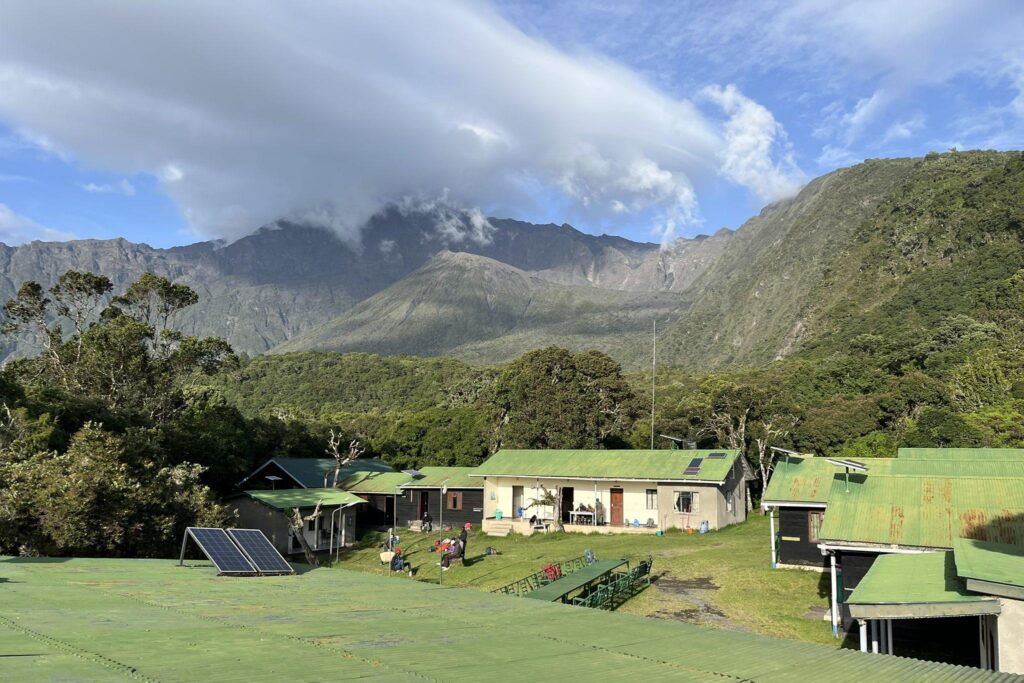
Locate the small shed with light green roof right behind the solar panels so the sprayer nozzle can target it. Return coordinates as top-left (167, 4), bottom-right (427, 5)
top-left (230, 488), bottom-right (365, 556)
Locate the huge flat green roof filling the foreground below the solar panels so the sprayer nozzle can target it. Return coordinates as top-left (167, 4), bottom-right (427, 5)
top-left (0, 558), bottom-right (1019, 683)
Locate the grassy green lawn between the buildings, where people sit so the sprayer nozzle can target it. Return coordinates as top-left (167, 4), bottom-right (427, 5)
top-left (338, 513), bottom-right (838, 644)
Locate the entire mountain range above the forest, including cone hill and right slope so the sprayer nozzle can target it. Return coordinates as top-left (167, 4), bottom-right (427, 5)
top-left (0, 152), bottom-right (1024, 370)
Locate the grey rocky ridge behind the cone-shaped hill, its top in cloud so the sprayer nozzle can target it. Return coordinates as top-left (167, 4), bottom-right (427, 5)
top-left (0, 210), bottom-right (732, 354)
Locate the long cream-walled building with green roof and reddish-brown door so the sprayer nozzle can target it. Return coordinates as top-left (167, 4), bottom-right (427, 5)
top-left (473, 450), bottom-right (751, 535)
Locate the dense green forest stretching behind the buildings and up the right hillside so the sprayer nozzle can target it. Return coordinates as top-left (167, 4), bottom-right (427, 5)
top-left (0, 154), bottom-right (1024, 556)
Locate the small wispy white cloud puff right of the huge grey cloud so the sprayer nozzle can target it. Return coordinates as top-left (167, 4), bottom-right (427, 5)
top-left (701, 85), bottom-right (807, 202)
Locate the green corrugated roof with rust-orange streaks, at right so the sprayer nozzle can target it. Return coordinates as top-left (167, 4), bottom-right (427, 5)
top-left (820, 473), bottom-right (1024, 549)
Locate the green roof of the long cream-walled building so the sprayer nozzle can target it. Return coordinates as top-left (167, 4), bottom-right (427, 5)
top-left (474, 449), bottom-right (739, 481)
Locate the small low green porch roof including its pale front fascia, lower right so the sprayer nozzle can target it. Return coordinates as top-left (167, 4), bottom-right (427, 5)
top-left (846, 552), bottom-right (999, 618)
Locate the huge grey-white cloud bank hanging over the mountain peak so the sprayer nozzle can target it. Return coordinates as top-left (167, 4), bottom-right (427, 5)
top-left (0, 0), bottom-right (799, 245)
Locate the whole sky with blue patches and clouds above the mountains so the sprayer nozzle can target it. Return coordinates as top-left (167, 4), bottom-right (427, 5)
top-left (0, 0), bottom-right (1024, 247)
